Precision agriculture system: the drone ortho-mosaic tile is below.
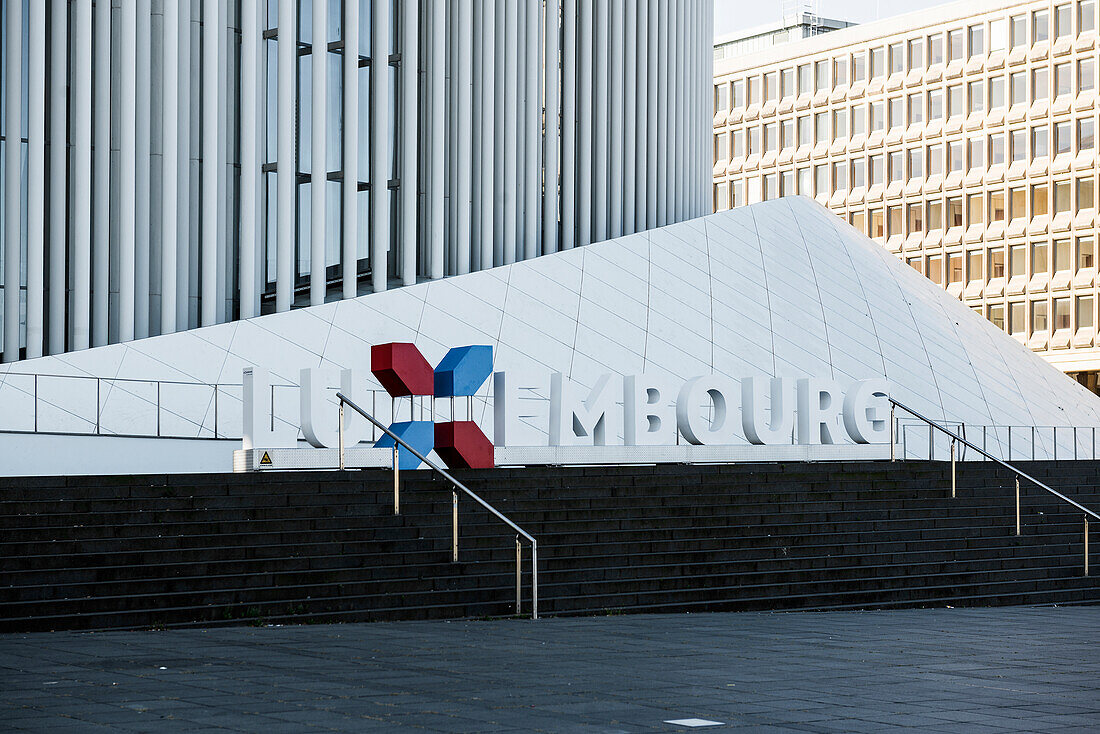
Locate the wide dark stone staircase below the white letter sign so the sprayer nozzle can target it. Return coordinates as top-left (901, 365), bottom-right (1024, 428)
top-left (0, 461), bottom-right (1100, 632)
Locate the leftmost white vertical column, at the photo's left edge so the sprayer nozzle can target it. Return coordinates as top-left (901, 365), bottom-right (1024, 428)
top-left (3, 2), bottom-right (23, 362)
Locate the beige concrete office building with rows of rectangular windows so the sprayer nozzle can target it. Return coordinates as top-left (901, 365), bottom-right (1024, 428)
top-left (714, 0), bottom-right (1100, 390)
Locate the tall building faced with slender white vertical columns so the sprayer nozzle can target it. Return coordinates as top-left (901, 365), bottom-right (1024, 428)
top-left (0, 0), bottom-right (712, 362)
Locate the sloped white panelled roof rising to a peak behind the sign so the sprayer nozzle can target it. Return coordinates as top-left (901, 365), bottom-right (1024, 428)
top-left (0, 197), bottom-right (1100, 444)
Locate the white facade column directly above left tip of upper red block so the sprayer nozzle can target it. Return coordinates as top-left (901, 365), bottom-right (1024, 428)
top-left (371, 2), bottom-right (391, 293)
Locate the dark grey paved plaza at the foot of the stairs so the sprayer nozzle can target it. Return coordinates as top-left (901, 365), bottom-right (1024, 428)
top-left (0, 606), bottom-right (1100, 734)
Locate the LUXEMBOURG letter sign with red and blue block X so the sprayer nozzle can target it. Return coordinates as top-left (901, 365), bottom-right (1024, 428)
top-left (243, 342), bottom-right (890, 469)
